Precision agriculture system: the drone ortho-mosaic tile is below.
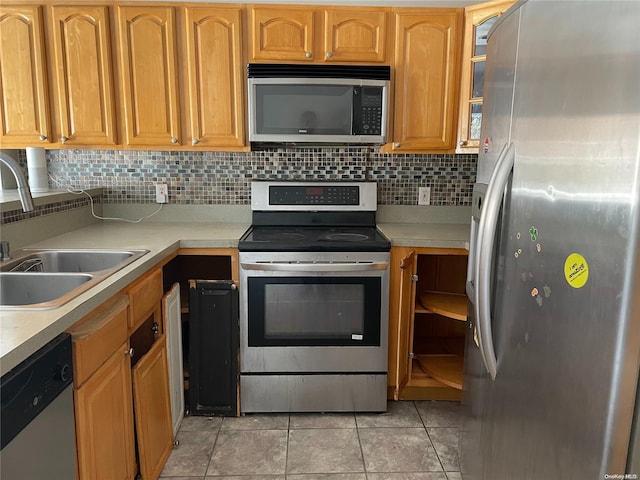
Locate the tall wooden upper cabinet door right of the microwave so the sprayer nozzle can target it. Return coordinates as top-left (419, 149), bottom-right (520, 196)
top-left (392, 9), bottom-right (462, 152)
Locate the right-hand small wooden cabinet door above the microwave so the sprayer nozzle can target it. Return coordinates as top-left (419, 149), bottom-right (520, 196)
top-left (323, 8), bottom-right (387, 62)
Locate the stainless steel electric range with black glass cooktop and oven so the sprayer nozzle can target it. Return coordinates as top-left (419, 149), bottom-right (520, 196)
top-left (238, 182), bottom-right (390, 413)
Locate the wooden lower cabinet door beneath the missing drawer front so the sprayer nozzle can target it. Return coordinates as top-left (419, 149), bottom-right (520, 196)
top-left (133, 335), bottom-right (173, 479)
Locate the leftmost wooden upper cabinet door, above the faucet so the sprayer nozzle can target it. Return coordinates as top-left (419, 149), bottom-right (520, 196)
top-left (0, 5), bottom-right (49, 148)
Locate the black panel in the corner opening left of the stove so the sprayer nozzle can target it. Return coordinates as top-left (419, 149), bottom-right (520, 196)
top-left (189, 280), bottom-right (239, 416)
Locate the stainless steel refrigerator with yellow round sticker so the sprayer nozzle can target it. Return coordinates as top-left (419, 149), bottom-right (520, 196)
top-left (461, 0), bottom-right (640, 480)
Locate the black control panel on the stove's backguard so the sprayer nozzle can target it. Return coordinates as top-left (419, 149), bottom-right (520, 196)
top-left (269, 185), bottom-right (360, 206)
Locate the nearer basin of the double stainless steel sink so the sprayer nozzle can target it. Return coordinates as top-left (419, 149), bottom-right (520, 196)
top-left (0, 273), bottom-right (94, 308)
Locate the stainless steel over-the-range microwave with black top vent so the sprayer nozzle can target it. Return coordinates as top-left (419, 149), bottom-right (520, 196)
top-left (247, 63), bottom-right (391, 144)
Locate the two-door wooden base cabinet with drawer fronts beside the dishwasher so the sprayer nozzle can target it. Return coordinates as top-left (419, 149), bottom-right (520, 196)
top-left (69, 268), bottom-right (173, 480)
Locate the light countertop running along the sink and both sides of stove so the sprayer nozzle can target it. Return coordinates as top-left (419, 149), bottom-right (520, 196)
top-left (0, 222), bottom-right (469, 375)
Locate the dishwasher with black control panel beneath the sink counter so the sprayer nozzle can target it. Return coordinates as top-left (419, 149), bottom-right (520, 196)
top-left (0, 333), bottom-right (76, 480)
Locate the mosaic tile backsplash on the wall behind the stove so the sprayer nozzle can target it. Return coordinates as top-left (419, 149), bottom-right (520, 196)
top-left (3, 147), bottom-right (477, 220)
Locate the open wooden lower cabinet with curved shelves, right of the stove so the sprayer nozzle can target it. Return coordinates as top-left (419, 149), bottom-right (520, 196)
top-left (388, 247), bottom-right (467, 400)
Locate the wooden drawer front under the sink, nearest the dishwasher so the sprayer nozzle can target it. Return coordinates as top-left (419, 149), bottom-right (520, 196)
top-left (69, 296), bottom-right (129, 388)
